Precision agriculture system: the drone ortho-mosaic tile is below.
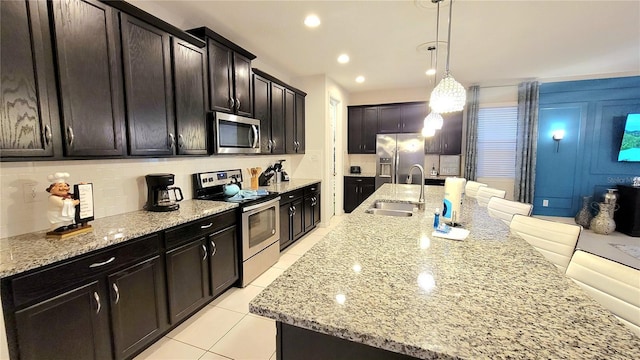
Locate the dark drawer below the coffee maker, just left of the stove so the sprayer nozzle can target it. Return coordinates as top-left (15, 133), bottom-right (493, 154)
top-left (164, 210), bottom-right (236, 250)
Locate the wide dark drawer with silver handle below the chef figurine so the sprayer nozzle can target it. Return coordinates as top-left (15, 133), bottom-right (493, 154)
top-left (10, 234), bottom-right (160, 307)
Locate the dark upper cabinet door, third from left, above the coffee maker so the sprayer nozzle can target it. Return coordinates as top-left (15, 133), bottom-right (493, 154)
top-left (120, 14), bottom-right (175, 155)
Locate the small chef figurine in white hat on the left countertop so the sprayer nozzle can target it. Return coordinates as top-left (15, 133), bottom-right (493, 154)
top-left (47, 172), bottom-right (80, 232)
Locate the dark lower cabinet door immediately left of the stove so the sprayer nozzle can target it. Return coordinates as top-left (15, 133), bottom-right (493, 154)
top-left (209, 226), bottom-right (240, 297)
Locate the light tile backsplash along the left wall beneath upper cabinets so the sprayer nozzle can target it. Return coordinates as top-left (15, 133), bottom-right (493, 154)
top-left (0, 155), bottom-right (302, 238)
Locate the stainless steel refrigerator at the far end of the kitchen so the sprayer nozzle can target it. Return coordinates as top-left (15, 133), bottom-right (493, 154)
top-left (376, 133), bottom-right (424, 189)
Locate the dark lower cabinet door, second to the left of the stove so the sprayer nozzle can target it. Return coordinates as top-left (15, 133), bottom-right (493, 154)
top-left (166, 238), bottom-right (209, 324)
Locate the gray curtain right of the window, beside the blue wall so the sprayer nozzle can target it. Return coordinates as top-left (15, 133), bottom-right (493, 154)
top-left (513, 81), bottom-right (540, 204)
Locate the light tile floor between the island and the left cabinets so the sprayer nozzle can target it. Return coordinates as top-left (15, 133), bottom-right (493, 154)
top-left (134, 216), bottom-right (345, 360)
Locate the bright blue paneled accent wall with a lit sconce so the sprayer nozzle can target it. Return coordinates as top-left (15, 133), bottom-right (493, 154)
top-left (534, 76), bottom-right (640, 216)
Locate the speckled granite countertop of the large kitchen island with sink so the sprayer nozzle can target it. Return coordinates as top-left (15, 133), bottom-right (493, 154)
top-left (250, 184), bottom-right (640, 359)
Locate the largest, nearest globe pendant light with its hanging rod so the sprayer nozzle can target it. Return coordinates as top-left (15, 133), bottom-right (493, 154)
top-left (429, 0), bottom-right (467, 114)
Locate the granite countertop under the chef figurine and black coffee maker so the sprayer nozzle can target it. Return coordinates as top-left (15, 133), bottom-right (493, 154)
top-left (0, 200), bottom-right (238, 278)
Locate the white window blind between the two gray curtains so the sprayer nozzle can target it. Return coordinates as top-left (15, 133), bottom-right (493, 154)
top-left (477, 106), bottom-right (518, 178)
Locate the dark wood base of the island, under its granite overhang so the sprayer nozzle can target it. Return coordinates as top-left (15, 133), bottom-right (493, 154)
top-left (276, 321), bottom-right (416, 360)
